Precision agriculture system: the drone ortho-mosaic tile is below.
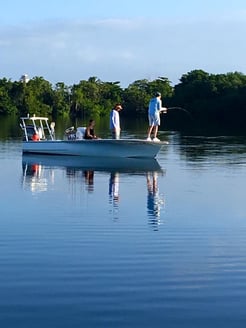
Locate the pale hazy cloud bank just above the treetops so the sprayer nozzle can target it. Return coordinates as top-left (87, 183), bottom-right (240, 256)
top-left (0, 18), bottom-right (246, 86)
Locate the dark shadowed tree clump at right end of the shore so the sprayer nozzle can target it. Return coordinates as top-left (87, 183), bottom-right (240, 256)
top-left (173, 70), bottom-right (246, 125)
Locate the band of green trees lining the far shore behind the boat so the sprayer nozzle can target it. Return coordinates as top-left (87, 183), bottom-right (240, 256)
top-left (0, 70), bottom-right (246, 129)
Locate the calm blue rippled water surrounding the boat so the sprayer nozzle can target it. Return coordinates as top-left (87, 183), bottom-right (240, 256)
top-left (0, 129), bottom-right (246, 328)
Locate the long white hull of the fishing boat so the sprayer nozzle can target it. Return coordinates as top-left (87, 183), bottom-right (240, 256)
top-left (22, 139), bottom-right (165, 158)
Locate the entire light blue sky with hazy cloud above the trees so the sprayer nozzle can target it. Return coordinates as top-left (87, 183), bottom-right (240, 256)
top-left (0, 0), bottom-right (246, 87)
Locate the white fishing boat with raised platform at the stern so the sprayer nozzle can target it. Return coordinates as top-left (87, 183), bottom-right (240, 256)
top-left (20, 115), bottom-right (168, 158)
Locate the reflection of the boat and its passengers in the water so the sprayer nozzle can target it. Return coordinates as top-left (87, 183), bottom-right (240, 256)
top-left (22, 155), bottom-right (164, 226)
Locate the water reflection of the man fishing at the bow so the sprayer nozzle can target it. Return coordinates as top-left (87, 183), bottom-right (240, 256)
top-left (147, 172), bottom-right (163, 230)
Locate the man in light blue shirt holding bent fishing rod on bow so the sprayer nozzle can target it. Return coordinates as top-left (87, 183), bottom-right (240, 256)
top-left (147, 92), bottom-right (167, 141)
